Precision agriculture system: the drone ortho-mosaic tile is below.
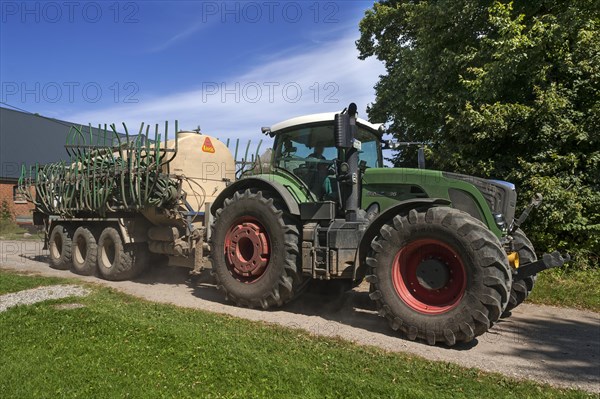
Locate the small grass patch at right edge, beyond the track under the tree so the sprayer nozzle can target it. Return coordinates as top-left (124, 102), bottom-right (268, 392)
top-left (527, 269), bottom-right (600, 312)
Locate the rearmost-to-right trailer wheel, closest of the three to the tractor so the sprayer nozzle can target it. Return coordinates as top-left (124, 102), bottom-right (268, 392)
top-left (97, 227), bottom-right (148, 281)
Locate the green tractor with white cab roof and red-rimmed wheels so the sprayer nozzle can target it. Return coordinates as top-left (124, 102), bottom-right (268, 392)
top-left (208, 104), bottom-right (569, 345)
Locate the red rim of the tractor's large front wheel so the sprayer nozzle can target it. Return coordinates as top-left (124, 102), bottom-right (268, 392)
top-left (392, 239), bottom-right (467, 314)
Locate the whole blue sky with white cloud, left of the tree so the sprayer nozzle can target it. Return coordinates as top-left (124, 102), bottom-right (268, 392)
top-left (0, 1), bottom-right (384, 145)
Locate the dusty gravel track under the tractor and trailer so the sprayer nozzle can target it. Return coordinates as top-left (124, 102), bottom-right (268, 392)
top-left (0, 241), bottom-right (600, 394)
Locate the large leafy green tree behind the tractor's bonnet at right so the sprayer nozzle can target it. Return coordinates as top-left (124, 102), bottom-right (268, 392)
top-left (357, 0), bottom-right (600, 268)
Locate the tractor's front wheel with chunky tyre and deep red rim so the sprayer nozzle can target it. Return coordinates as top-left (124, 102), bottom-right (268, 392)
top-left (367, 207), bottom-right (512, 346)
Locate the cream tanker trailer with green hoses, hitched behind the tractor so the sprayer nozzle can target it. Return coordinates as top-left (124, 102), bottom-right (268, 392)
top-left (19, 122), bottom-right (236, 280)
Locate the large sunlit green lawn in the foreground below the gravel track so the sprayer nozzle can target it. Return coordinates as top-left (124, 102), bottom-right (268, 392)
top-left (0, 272), bottom-right (591, 399)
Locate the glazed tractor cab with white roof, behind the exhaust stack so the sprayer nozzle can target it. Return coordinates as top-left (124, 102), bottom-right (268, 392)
top-left (267, 113), bottom-right (383, 201)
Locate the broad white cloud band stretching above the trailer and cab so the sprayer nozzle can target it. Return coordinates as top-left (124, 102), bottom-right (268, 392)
top-left (65, 30), bottom-right (384, 153)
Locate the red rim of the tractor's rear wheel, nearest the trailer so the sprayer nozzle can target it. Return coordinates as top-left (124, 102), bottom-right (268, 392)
top-left (224, 216), bottom-right (270, 283)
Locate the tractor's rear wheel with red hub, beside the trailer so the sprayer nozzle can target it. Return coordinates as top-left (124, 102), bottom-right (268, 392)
top-left (211, 189), bottom-right (301, 309)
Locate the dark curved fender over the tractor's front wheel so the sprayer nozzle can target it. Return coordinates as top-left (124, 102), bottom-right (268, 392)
top-left (354, 198), bottom-right (451, 281)
